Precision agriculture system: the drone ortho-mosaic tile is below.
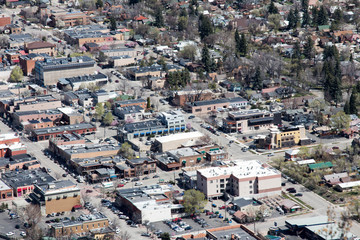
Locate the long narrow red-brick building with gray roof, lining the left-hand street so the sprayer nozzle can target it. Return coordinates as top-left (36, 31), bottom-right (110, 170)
top-left (31, 123), bottom-right (96, 141)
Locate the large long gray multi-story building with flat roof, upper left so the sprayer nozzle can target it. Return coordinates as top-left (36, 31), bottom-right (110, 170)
top-left (35, 56), bottom-right (96, 86)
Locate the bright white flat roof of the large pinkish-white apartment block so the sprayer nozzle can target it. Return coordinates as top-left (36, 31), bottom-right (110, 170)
top-left (198, 160), bottom-right (280, 178)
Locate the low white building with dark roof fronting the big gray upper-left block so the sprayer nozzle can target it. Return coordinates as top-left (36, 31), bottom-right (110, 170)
top-left (58, 73), bottom-right (108, 91)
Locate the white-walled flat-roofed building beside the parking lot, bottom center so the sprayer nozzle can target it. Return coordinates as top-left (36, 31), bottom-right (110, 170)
top-left (115, 185), bottom-right (184, 223)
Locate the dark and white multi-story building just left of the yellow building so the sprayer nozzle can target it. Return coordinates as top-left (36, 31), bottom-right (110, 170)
top-left (223, 109), bottom-right (281, 133)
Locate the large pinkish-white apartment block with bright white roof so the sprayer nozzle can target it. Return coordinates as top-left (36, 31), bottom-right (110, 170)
top-left (197, 160), bottom-right (281, 198)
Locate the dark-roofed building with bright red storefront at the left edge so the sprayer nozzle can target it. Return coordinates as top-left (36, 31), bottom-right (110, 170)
top-left (1, 169), bottom-right (55, 197)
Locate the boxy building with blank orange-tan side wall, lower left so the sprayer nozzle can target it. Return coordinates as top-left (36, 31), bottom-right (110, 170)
top-left (30, 180), bottom-right (81, 215)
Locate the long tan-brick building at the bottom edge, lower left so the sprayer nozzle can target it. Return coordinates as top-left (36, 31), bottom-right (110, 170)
top-left (51, 212), bottom-right (110, 239)
